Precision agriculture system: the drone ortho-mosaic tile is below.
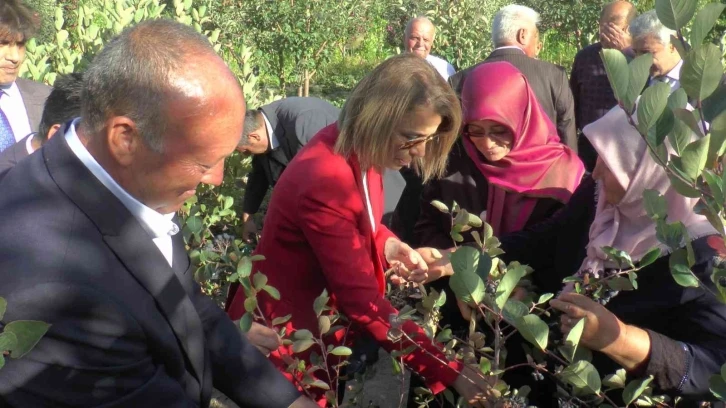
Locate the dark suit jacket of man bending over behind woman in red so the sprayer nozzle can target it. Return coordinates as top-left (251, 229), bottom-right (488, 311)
top-left (243, 98), bottom-right (340, 214)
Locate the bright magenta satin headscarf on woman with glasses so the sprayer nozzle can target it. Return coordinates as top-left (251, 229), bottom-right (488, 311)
top-left (461, 62), bottom-right (585, 234)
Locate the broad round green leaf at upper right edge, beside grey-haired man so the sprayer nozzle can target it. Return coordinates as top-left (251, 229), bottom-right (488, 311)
top-left (680, 44), bottom-right (723, 101)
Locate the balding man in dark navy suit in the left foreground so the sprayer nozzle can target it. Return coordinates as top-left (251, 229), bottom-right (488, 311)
top-left (0, 19), bottom-right (316, 408)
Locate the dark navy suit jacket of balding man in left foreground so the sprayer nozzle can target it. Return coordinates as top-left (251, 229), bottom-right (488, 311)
top-left (0, 133), bottom-right (299, 408)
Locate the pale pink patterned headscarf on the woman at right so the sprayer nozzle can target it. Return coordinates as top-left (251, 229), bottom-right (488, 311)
top-left (581, 103), bottom-right (716, 273)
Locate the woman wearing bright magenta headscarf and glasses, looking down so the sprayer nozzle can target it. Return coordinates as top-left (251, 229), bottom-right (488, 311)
top-left (415, 62), bottom-right (585, 270)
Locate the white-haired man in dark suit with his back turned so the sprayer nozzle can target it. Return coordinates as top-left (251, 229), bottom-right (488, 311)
top-left (449, 5), bottom-right (577, 151)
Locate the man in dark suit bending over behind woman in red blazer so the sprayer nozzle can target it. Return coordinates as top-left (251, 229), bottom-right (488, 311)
top-left (237, 97), bottom-right (406, 238)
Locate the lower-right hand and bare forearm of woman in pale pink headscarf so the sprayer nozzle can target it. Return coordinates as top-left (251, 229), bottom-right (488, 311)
top-left (550, 293), bottom-right (650, 371)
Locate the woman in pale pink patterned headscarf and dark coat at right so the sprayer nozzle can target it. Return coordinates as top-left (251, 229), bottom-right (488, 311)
top-left (500, 103), bottom-right (726, 406)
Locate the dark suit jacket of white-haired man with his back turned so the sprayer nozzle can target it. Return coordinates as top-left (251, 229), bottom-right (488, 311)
top-left (449, 48), bottom-right (577, 152)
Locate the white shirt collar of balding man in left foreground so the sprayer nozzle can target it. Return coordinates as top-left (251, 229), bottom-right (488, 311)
top-left (65, 119), bottom-right (179, 266)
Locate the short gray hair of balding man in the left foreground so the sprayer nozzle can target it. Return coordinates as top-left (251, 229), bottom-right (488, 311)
top-left (81, 19), bottom-right (216, 152)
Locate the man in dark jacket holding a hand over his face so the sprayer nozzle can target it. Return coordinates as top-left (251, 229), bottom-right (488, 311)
top-left (570, 0), bottom-right (637, 171)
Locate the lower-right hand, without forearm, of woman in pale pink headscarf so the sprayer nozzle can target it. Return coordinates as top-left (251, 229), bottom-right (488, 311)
top-left (550, 293), bottom-right (626, 351)
